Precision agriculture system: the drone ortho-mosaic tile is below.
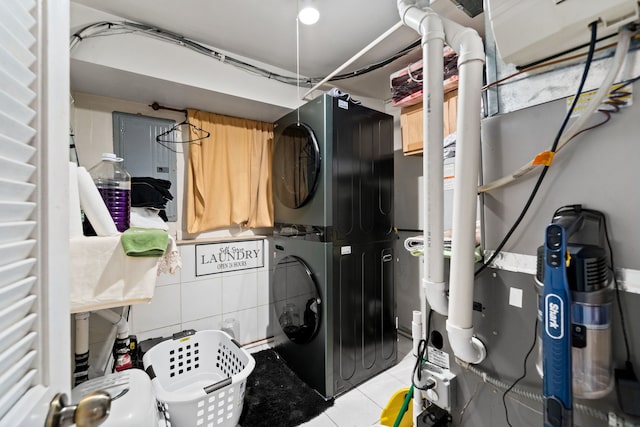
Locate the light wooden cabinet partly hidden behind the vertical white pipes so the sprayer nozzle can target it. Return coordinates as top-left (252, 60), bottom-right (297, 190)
top-left (400, 88), bottom-right (458, 156)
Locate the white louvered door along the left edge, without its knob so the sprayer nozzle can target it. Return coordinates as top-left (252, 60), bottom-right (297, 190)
top-left (0, 0), bottom-right (70, 427)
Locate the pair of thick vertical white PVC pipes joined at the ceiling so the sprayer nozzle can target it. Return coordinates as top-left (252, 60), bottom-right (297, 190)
top-left (397, 0), bottom-right (486, 370)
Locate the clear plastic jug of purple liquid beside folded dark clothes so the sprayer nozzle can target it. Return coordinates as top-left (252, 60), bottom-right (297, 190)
top-left (89, 153), bottom-right (131, 232)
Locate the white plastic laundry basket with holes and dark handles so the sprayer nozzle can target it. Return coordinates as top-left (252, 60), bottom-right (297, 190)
top-left (142, 330), bottom-right (255, 427)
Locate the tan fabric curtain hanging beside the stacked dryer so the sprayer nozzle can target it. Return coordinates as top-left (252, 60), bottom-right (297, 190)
top-left (186, 109), bottom-right (273, 233)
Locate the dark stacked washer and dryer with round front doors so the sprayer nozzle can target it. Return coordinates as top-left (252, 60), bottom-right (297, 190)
top-left (270, 94), bottom-right (397, 398)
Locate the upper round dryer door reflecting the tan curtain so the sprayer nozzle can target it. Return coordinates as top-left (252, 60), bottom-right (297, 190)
top-left (273, 123), bottom-right (320, 209)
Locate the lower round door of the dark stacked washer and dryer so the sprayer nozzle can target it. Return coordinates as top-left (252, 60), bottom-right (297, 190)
top-left (273, 255), bottom-right (322, 344)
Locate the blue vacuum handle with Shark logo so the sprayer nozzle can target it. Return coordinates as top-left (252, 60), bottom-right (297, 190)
top-left (542, 224), bottom-right (573, 427)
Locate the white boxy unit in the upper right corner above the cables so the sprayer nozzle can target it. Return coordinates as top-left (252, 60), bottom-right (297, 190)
top-left (486, 0), bottom-right (640, 65)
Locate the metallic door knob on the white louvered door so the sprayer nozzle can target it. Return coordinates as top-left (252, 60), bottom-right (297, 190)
top-left (45, 390), bottom-right (111, 427)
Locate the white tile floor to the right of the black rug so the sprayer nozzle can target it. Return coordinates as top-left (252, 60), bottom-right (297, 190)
top-left (247, 334), bottom-right (414, 427)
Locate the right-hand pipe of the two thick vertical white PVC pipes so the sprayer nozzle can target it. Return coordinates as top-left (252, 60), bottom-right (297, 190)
top-left (442, 18), bottom-right (486, 363)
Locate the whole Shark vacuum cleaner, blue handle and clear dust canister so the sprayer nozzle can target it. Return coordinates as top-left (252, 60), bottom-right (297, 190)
top-left (536, 205), bottom-right (614, 427)
